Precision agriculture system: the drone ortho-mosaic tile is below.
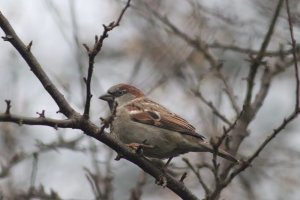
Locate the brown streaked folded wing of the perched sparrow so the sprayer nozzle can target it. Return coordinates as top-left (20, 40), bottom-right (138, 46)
top-left (126, 99), bottom-right (205, 140)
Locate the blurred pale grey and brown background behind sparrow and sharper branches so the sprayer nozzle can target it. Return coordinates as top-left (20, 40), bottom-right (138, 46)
top-left (0, 0), bottom-right (300, 200)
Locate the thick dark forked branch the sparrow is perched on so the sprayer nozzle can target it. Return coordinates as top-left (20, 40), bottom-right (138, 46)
top-left (0, 6), bottom-right (202, 200)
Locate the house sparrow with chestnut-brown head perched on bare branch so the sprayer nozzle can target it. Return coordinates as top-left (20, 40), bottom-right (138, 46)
top-left (99, 84), bottom-right (238, 162)
